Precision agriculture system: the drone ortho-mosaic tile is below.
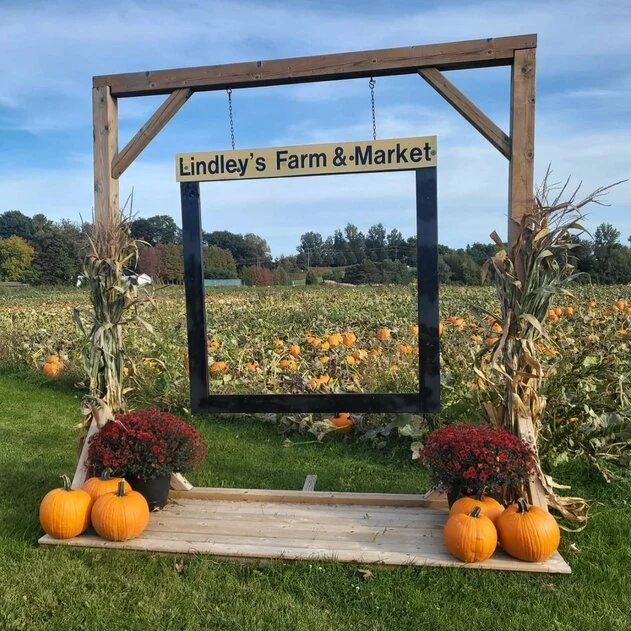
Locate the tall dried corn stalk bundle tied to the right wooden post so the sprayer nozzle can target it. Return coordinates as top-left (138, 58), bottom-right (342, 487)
top-left (475, 170), bottom-right (615, 521)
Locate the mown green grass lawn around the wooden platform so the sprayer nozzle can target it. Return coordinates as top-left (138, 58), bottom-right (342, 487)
top-left (0, 373), bottom-right (631, 631)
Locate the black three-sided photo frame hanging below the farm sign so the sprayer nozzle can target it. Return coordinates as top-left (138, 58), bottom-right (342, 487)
top-left (180, 166), bottom-right (440, 414)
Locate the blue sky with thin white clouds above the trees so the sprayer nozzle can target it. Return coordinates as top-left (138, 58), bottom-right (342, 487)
top-left (0, 0), bottom-right (631, 255)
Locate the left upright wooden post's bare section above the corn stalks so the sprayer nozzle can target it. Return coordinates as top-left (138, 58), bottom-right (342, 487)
top-left (92, 86), bottom-right (120, 227)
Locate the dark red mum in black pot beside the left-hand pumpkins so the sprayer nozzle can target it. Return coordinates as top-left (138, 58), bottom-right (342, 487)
top-left (87, 408), bottom-right (207, 510)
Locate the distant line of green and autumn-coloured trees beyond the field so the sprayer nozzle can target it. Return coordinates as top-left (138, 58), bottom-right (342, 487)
top-left (0, 210), bottom-right (631, 285)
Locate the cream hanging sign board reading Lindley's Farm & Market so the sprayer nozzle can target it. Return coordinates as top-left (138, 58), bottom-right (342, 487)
top-left (175, 136), bottom-right (437, 182)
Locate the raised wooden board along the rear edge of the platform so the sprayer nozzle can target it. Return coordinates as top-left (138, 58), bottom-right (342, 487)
top-left (170, 486), bottom-right (443, 506)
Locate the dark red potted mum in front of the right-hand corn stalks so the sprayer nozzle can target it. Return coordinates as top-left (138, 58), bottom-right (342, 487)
top-left (419, 423), bottom-right (535, 507)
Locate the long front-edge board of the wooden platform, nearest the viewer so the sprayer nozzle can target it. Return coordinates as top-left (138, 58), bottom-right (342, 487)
top-left (39, 535), bottom-right (570, 574)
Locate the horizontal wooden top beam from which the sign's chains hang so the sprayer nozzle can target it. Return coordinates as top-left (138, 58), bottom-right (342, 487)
top-left (93, 35), bottom-right (537, 97)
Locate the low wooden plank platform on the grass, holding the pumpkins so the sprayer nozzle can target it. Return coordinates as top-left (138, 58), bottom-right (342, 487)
top-left (39, 488), bottom-right (571, 574)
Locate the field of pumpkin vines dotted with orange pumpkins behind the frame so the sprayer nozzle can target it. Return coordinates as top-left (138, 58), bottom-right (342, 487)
top-left (0, 286), bottom-right (631, 454)
